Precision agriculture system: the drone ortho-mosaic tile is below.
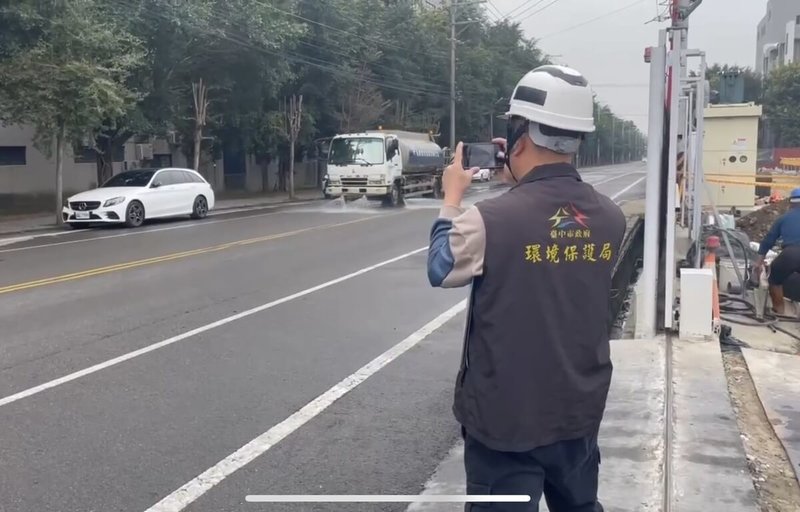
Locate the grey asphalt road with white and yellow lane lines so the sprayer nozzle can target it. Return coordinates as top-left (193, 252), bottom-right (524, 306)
top-left (0, 164), bottom-right (644, 512)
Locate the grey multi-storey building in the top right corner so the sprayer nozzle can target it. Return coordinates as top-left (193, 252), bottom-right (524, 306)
top-left (756, 0), bottom-right (800, 75)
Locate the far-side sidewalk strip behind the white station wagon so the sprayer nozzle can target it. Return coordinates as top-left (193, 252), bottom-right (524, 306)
top-left (0, 190), bottom-right (322, 235)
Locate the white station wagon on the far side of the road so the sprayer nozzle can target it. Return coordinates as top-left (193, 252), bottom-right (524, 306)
top-left (62, 168), bottom-right (215, 228)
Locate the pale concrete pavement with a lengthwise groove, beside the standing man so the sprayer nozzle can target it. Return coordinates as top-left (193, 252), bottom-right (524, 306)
top-left (408, 340), bottom-right (758, 512)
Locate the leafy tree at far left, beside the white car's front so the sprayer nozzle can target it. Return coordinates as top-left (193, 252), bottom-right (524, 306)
top-left (0, 0), bottom-right (143, 223)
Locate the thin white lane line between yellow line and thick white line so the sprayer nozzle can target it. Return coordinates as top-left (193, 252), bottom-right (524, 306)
top-left (0, 247), bottom-right (428, 407)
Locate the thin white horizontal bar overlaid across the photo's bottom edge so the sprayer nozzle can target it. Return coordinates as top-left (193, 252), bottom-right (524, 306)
top-left (244, 494), bottom-right (531, 503)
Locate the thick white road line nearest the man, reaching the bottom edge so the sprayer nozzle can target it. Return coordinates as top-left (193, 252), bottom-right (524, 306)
top-left (146, 300), bottom-right (467, 512)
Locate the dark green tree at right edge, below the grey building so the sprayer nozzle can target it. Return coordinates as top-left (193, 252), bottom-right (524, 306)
top-left (764, 63), bottom-right (800, 147)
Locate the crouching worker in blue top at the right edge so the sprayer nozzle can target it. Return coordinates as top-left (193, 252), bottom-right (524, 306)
top-left (754, 188), bottom-right (800, 316)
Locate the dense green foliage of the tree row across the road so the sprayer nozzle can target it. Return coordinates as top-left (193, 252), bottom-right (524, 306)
top-left (0, 0), bottom-right (644, 175)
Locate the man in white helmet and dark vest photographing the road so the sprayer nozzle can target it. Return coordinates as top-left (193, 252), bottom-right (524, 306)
top-left (428, 66), bottom-right (625, 512)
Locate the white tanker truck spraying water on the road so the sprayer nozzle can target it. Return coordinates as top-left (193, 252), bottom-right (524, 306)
top-left (323, 130), bottom-right (445, 206)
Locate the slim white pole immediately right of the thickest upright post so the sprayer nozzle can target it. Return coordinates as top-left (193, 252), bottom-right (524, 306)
top-left (664, 30), bottom-right (683, 330)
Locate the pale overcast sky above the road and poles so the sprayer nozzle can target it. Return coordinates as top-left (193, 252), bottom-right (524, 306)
top-left (485, 0), bottom-right (767, 131)
